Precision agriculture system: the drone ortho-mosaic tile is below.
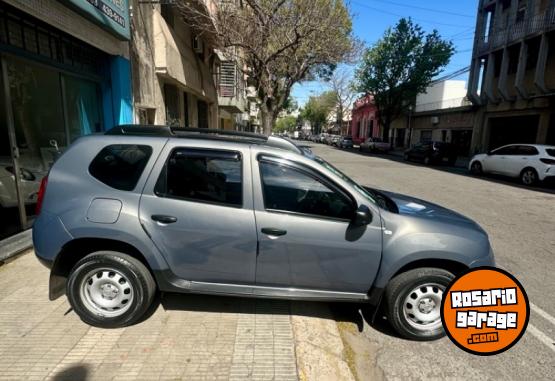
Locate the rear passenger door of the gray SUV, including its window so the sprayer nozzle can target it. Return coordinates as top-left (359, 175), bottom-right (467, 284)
top-left (140, 139), bottom-right (257, 284)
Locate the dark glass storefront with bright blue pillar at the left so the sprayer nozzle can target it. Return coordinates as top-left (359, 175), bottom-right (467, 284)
top-left (0, 0), bottom-right (133, 236)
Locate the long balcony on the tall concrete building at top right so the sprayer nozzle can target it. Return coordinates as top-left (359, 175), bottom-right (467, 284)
top-left (477, 7), bottom-right (555, 55)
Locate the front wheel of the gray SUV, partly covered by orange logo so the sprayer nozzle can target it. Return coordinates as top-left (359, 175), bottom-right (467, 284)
top-left (385, 267), bottom-right (455, 341)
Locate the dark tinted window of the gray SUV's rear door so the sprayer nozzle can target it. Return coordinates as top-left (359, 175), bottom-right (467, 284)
top-left (155, 149), bottom-right (243, 206)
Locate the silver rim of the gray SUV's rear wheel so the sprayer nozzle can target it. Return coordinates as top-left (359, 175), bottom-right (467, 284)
top-left (79, 268), bottom-right (134, 317)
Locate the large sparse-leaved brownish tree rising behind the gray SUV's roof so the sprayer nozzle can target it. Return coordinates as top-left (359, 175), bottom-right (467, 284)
top-left (180, 0), bottom-right (356, 134)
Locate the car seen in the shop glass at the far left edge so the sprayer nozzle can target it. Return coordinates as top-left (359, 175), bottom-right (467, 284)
top-left (0, 162), bottom-right (40, 208)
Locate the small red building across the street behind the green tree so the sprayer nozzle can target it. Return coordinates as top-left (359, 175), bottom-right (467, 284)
top-left (350, 95), bottom-right (381, 144)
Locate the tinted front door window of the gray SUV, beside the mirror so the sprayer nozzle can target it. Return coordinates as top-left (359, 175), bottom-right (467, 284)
top-left (260, 161), bottom-right (353, 220)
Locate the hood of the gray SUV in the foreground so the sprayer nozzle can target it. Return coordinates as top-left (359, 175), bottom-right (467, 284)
top-left (373, 189), bottom-right (486, 234)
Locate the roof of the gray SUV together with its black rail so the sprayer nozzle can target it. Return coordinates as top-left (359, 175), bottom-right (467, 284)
top-left (104, 124), bottom-right (305, 155)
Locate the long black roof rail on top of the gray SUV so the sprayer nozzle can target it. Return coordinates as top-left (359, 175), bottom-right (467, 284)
top-left (105, 125), bottom-right (268, 141)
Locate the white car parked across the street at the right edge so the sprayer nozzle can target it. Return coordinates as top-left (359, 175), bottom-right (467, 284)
top-left (468, 144), bottom-right (555, 185)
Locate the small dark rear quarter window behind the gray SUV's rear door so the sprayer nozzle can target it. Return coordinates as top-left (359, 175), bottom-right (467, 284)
top-left (89, 144), bottom-right (152, 191)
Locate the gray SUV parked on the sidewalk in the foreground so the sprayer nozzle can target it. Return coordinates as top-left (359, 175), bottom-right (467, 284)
top-left (33, 126), bottom-right (494, 340)
